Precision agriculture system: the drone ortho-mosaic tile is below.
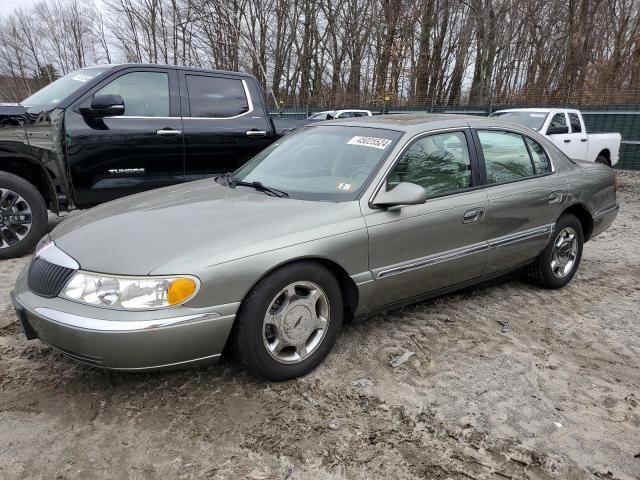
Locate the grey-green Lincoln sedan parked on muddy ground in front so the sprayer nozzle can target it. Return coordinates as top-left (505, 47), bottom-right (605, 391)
top-left (14, 115), bottom-right (618, 380)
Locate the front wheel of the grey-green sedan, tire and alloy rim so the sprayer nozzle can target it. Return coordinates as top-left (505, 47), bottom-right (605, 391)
top-left (232, 262), bottom-right (344, 381)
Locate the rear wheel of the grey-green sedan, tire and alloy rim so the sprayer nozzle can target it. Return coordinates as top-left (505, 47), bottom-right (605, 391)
top-left (526, 213), bottom-right (584, 289)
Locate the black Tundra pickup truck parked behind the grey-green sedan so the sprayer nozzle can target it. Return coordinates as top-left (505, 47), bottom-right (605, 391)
top-left (0, 64), bottom-right (296, 259)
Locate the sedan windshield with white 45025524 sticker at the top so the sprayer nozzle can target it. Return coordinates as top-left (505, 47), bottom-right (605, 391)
top-left (229, 125), bottom-right (402, 202)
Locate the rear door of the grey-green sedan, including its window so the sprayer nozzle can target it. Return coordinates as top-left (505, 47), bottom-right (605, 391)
top-left (474, 129), bottom-right (567, 274)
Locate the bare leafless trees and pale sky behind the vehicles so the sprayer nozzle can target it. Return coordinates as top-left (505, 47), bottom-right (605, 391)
top-left (0, 0), bottom-right (640, 107)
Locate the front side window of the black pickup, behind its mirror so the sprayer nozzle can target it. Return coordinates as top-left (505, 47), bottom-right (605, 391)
top-left (95, 72), bottom-right (169, 117)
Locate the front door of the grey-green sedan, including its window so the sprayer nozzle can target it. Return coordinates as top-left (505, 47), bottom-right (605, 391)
top-left (365, 129), bottom-right (488, 308)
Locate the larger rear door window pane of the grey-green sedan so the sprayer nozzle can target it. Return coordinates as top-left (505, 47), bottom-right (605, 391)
top-left (478, 130), bottom-right (534, 183)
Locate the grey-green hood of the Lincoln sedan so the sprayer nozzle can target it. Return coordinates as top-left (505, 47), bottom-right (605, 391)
top-left (51, 179), bottom-right (364, 275)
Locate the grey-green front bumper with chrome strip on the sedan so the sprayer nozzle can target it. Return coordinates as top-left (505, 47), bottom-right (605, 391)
top-left (12, 272), bottom-right (239, 371)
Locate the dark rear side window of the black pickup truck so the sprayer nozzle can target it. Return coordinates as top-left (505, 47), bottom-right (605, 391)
top-left (185, 75), bottom-right (249, 118)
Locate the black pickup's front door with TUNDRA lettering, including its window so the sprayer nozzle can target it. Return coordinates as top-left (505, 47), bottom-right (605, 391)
top-left (64, 67), bottom-right (184, 207)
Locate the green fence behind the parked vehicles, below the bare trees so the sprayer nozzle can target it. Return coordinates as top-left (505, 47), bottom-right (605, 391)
top-left (272, 105), bottom-right (640, 170)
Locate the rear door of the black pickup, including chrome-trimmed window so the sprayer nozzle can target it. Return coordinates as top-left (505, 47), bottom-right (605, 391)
top-left (180, 71), bottom-right (275, 180)
